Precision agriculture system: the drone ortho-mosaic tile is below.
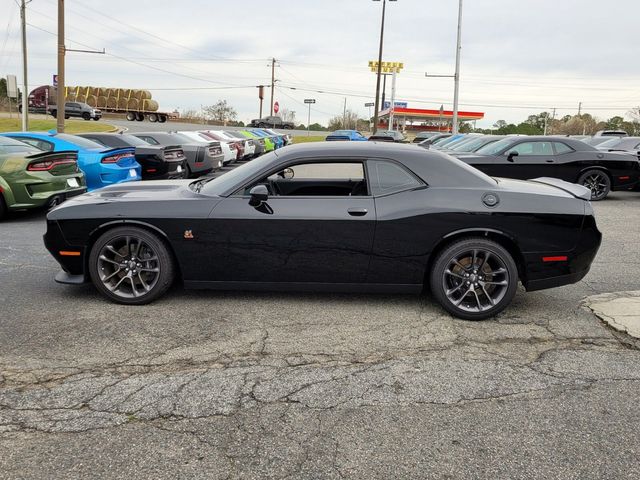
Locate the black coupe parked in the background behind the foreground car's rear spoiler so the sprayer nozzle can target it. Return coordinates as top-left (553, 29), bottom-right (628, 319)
top-left (456, 136), bottom-right (640, 200)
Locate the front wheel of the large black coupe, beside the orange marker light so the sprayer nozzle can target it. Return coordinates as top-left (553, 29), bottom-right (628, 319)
top-left (89, 227), bottom-right (175, 305)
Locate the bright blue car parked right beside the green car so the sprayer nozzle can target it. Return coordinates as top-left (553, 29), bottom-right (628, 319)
top-left (1, 132), bottom-right (141, 191)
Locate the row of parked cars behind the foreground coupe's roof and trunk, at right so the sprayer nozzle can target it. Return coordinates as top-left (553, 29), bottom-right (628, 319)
top-left (326, 130), bottom-right (640, 200)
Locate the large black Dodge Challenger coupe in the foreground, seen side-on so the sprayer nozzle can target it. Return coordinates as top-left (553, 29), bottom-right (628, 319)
top-left (44, 142), bottom-right (601, 320)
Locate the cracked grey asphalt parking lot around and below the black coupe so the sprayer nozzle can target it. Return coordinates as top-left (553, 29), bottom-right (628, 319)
top-left (0, 185), bottom-right (640, 479)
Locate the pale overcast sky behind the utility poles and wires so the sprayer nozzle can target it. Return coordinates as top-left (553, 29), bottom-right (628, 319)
top-left (0, 0), bottom-right (640, 127)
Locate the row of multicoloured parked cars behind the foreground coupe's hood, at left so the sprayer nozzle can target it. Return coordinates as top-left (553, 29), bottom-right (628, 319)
top-left (0, 129), bottom-right (292, 218)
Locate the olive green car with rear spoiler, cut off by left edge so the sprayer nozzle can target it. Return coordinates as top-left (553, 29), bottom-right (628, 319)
top-left (0, 136), bottom-right (87, 219)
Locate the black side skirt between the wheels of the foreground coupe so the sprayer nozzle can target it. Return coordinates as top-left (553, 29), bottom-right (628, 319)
top-left (184, 281), bottom-right (423, 294)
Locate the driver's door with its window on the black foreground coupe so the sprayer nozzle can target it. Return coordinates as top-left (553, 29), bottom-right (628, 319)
top-left (202, 159), bottom-right (376, 288)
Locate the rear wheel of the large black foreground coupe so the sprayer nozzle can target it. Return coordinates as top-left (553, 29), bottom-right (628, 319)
top-left (430, 238), bottom-right (518, 320)
